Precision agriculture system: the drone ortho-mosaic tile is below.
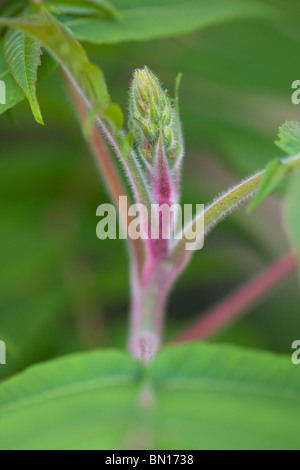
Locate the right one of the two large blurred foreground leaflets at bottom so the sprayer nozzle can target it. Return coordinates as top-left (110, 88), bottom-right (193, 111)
top-left (153, 344), bottom-right (300, 450)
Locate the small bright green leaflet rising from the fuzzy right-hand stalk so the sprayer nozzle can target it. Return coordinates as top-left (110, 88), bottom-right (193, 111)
top-left (248, 158), bottom-right (290, 212)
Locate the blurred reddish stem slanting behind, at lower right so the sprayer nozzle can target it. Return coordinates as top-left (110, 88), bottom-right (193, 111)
top-left (175, 253), bottom-right (297, 343)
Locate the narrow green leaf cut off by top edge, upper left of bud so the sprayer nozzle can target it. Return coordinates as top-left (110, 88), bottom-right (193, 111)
top-left (44, 0), bottom-right (121, 20)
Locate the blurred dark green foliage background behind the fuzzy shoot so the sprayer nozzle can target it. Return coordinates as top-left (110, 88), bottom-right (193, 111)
top-left (0, 5), bottom-right (300, 378)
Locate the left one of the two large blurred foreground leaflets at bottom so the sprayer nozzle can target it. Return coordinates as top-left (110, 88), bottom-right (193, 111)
top-left (0, 351), bottom-right (141, 449)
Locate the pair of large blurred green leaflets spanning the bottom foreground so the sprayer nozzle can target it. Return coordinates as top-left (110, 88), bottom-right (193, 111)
top-left (0, 343), bottom-right (300, 450)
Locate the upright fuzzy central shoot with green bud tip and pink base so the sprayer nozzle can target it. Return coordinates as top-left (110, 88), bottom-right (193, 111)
top-left (124, 67), bottom-right (183, 362)
